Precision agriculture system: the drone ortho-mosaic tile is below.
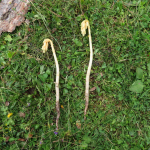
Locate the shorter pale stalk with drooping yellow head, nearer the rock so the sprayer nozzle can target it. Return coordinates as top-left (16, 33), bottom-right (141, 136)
top-left (42, 39), bottom-right (60, 130)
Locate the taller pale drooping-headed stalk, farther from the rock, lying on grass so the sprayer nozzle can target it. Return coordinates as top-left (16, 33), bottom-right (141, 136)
top-left (81, 20), bottom-right (93, 120)
